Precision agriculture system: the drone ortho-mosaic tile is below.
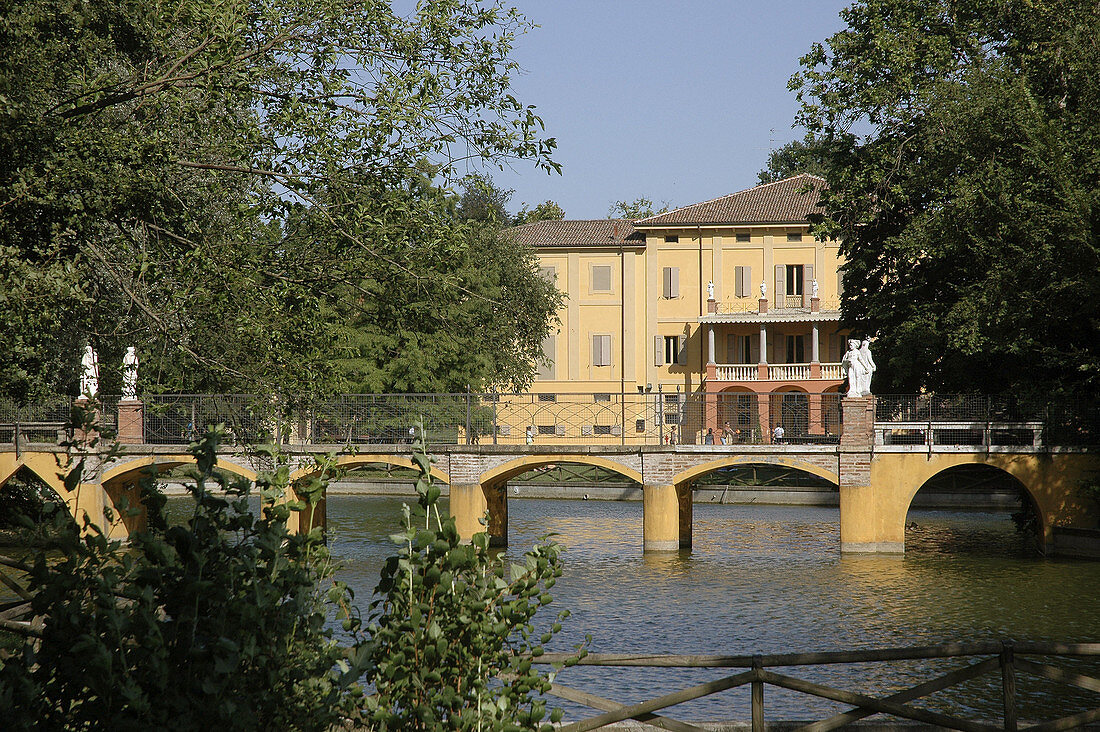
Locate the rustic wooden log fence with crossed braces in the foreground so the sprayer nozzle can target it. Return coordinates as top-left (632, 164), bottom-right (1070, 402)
top-left (532, 641), bottom-right (1100, 732)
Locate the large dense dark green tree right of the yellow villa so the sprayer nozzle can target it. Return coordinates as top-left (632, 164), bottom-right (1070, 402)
top-left (790, 0), bottom-right (1100, 394)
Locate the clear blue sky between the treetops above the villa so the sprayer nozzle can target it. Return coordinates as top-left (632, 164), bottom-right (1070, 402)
top-left (490, 0), bottom-right (849, 219)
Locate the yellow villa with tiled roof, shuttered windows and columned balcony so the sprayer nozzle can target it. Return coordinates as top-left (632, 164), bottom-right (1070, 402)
top-left (509, 175), bottom-right (845, 443)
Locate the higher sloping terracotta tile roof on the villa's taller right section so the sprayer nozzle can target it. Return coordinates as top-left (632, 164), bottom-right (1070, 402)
top-left (635, 175), bottom-right (825, 229)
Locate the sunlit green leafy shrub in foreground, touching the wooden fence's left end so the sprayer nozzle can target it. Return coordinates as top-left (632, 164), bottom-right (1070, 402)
top-left (366, 429), bottom-right (584, 731)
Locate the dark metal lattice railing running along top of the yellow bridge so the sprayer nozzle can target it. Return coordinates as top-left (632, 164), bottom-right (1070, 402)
top-left (0, 391), bottom-right (1100, 446)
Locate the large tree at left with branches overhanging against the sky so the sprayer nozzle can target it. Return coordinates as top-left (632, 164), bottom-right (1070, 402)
top-left (0, 0), bottom-right (557, 398)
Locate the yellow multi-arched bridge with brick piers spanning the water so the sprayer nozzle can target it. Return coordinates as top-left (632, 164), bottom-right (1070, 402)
top-left (0, 397), bottom-right (1100, 553)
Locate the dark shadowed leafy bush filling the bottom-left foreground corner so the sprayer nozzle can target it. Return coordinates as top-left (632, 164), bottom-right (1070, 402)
top-left (0, 431), bottom-right (362, 730)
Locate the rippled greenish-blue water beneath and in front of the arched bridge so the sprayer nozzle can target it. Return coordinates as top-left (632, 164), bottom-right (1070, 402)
top-left (328, 495), bottom-right (1100, 721)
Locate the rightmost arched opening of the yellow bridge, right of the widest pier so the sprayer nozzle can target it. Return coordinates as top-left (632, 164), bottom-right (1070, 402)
top-left (905, 463), bottom-right (1042, 556)
